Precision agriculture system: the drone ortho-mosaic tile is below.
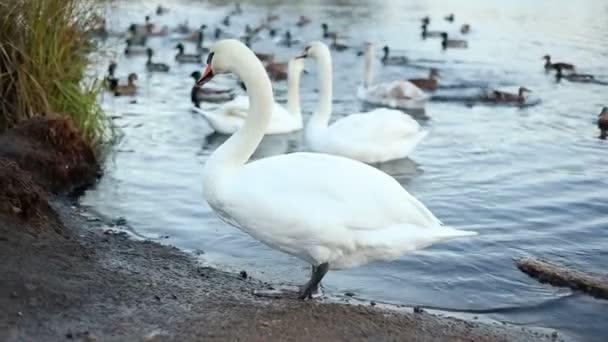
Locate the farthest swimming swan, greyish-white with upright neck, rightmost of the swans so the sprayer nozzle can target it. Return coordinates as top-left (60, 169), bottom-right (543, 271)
top-left (357, 43), bottom-right (428, 109)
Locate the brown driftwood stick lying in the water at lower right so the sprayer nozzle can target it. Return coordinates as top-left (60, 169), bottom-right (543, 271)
top-left (517, 258), bottom-right (608, 299)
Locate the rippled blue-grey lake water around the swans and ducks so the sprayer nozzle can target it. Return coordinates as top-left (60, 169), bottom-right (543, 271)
top-left (82, 0), bottom-right (608, 341)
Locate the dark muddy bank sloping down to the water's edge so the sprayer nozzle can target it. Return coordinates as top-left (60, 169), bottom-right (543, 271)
top-left (0, 119), bottom-right (564, 341)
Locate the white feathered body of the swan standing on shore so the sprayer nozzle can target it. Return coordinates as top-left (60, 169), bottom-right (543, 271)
top-left (205, 153), bottom-right (472, 267)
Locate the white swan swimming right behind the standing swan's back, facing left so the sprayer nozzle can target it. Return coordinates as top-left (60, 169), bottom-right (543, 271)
top-left (300, 42), bottom-right (427, 164)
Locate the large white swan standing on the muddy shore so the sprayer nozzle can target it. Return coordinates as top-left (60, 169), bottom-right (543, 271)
top-left (198, 39), bottom-right (476, 299)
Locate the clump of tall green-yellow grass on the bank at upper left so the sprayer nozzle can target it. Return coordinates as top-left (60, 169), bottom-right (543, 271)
top-left (0, 0), bottom-right (108, 145)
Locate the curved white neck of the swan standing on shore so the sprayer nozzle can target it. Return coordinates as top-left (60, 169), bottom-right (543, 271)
top-left (207, 53), bottom-right (274, 173)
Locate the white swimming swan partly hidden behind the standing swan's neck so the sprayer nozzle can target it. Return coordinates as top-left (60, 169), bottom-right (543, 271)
top-left (199, 56), bottom-right (304, 134)
